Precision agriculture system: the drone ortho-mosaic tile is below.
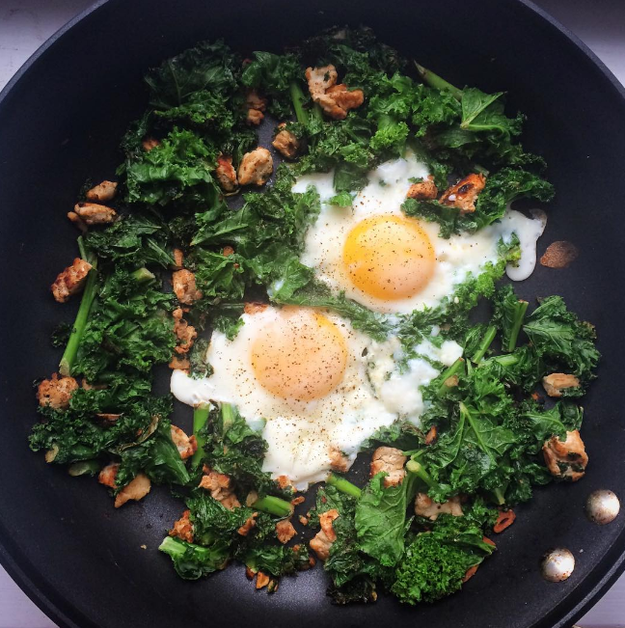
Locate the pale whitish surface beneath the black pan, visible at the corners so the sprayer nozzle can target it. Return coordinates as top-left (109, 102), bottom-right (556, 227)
top-left (0, 0), bottom-right (625, 628)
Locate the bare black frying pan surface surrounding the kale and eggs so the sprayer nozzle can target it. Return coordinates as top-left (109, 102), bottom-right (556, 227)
top-left (0, 0), bottom-right (625, 628)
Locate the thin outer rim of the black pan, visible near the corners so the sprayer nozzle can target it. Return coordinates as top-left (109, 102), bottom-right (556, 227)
top-left (0, 0), bottom-right (625, 628)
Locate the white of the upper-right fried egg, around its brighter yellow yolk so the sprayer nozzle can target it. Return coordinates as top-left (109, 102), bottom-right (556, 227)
top-left (292, 153), bottom-right (544, 314)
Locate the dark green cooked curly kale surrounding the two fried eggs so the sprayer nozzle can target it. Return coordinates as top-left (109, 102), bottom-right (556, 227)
top-left (35, 28), bottom-right (600, 604)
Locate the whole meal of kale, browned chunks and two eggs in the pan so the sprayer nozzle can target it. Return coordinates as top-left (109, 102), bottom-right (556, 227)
top-left (31, 29), bottom-right (599, 604)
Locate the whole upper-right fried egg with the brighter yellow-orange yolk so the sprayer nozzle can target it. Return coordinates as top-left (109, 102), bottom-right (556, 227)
top-left (292, 154), bottom-right (544, 314)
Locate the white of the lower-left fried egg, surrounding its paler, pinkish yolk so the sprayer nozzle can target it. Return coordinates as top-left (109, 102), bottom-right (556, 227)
top-left (171, 307), bottom-right (462, 490)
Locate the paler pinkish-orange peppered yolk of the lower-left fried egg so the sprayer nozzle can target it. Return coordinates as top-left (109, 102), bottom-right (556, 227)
top-left (252, 308), bottom-right (347, 401)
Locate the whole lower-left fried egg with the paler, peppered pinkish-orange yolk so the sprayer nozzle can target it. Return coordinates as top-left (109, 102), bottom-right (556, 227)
top-left (171, 306), bottom-right (462, 490)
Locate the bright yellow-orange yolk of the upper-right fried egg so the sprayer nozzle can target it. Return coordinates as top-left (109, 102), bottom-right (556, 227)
top-left (343, 215), bottom-right (436, 301)
